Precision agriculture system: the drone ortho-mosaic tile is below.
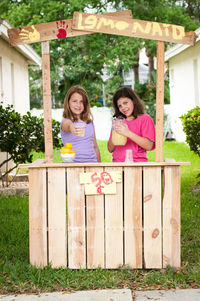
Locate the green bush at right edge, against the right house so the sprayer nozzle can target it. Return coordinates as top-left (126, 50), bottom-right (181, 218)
top-left (180, 107), bottom-right (200, 157)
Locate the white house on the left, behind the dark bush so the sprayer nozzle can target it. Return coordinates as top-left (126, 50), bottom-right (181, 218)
top-left (0, 18), bottom-right (41, 171)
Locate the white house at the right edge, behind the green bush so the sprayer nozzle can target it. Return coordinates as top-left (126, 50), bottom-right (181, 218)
top-left (165, 28), bottom-right (200, 141)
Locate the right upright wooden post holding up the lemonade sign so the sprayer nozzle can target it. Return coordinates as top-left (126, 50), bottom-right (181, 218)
top-left (156, 41), bottom-right (165, 162)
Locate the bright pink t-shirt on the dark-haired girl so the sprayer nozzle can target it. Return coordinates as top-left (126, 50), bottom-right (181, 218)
top-left (110, 114), bottom-right (155, 162)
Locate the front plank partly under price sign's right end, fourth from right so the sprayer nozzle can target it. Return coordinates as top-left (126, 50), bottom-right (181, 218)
top-left (105, 167), bottom-right (124, 269)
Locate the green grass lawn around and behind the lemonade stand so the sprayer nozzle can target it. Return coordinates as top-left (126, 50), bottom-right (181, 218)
top-left (0, 141), bottom-right (200, 294)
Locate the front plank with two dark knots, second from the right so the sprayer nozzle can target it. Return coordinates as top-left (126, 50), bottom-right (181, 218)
top-left (143, 167), bottom-right (162, 269)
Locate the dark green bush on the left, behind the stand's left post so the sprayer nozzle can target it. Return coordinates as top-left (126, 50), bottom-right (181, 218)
top-left (0, 103), bottom-right (62, 178)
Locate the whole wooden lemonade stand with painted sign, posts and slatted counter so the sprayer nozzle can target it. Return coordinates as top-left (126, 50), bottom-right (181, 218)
top-left (8, 11), bottom-right (196, 269)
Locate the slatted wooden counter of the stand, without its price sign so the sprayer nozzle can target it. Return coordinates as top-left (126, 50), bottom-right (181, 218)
top-left (29, 162), bottom-right (187, 269)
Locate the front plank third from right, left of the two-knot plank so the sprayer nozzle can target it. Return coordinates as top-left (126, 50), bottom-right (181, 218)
top-left (124, 167), bottom-right (142, 268)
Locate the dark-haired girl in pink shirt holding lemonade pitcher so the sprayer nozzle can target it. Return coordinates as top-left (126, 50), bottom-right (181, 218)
top-left (108, 87), bottom-right (155, 162)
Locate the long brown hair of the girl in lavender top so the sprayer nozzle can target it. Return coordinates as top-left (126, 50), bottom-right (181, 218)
top-left (63, 86), bottom-right (93, 123)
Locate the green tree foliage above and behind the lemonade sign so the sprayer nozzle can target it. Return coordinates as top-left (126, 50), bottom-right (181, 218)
top-left (0, 0), bottom-right (199, 104)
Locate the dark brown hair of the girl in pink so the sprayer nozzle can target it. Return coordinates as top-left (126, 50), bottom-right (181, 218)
top-left (113, 87), bottom-right (145, 118)
